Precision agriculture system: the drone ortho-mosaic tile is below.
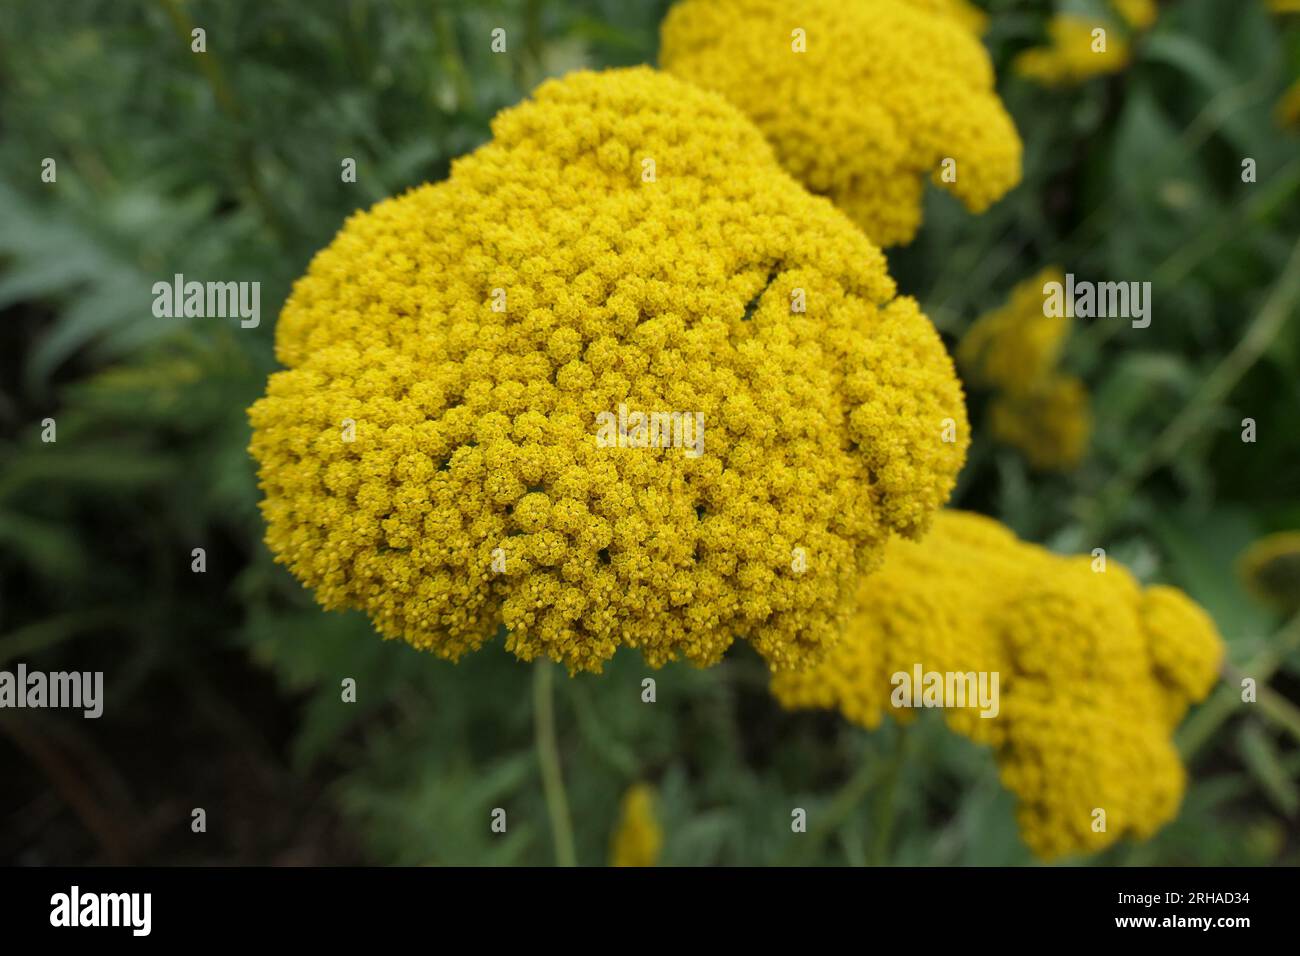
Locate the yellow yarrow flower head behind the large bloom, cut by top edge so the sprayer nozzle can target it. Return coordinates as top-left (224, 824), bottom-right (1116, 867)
top-left (659, 0), bottom-right (1021, 246)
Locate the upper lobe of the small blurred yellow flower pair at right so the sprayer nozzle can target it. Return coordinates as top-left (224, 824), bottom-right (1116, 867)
top-left (957, 265), bottom-right (1070, 394)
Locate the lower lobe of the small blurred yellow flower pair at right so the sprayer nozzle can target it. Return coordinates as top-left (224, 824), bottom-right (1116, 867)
top-left (988, 375), bottom-right (1092, 471)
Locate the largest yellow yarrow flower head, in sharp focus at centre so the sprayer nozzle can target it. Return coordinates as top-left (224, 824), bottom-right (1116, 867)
top-left (250, 68), bottom-right (969, 670)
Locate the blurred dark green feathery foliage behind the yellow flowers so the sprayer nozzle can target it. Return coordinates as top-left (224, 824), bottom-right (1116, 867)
top-left (0, 0), bottom-right (1300, 865)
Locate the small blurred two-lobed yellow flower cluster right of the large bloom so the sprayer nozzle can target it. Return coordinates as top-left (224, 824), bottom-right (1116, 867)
top-left (957, 265), bottom-right (1092, 470)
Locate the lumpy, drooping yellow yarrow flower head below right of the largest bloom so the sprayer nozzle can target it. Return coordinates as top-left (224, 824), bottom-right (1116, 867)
top-left (772, 511), bottom-right (1222, 858)
